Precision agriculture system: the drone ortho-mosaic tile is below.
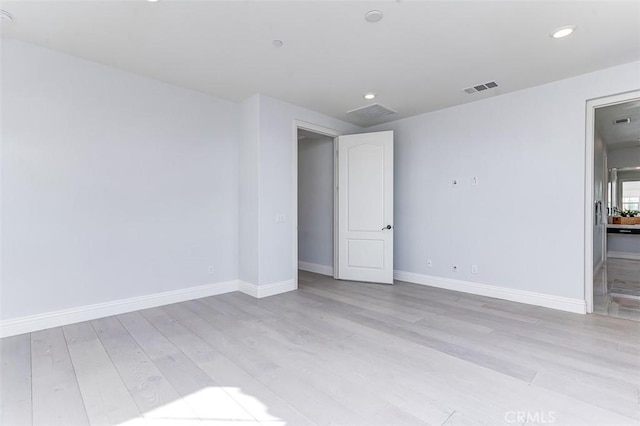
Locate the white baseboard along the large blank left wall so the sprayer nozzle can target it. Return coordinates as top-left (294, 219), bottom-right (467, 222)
top-left (0, 280), bottom-right (238, 337)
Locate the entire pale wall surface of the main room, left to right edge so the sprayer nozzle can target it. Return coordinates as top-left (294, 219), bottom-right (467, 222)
top-left (1, 40), bottom-right (640, 319)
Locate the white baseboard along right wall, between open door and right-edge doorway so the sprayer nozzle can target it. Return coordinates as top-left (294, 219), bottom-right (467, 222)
top-left (393, 271), bottom-right (587, 314)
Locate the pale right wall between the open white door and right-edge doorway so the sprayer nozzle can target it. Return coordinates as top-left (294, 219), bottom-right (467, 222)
top-left (368, 62), bottom-right (640, 299)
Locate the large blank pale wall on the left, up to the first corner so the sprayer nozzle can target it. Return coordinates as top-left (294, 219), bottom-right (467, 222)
top-left (1, 39), bottom-right (241, 319)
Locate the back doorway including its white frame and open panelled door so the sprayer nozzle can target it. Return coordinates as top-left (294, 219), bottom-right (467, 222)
top-left (292, 122), bottom-right (394, 284)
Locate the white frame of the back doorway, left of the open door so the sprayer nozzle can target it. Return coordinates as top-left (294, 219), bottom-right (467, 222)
top-left (291, 120), bottom-right (344, 282)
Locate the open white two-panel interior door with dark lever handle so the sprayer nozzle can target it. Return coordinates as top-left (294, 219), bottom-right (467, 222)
top-left (337, 131), bottom-right (393, 284)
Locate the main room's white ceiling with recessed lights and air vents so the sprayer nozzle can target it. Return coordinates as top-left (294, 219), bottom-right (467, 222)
top-left (2, 0), bottom-right (640, 125)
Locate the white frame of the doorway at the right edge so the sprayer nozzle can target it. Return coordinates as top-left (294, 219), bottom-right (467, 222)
top-left (584, 90), bottom-right (640, 313)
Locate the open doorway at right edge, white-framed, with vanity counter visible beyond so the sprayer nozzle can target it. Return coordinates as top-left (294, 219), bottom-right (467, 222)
top-left (585, 92), bottom-right (640, 320)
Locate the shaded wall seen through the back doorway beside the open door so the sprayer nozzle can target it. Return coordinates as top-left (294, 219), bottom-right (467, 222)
top-left (298, 136), bottom-right (333, 267)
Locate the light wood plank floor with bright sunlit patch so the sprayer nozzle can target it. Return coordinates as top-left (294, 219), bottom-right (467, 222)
top-left (0, 272), bottom-right (640, 426)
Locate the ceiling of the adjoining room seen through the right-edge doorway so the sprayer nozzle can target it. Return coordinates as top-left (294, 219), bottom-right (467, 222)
top-left (595, 100), bottom-right (640, 150)
